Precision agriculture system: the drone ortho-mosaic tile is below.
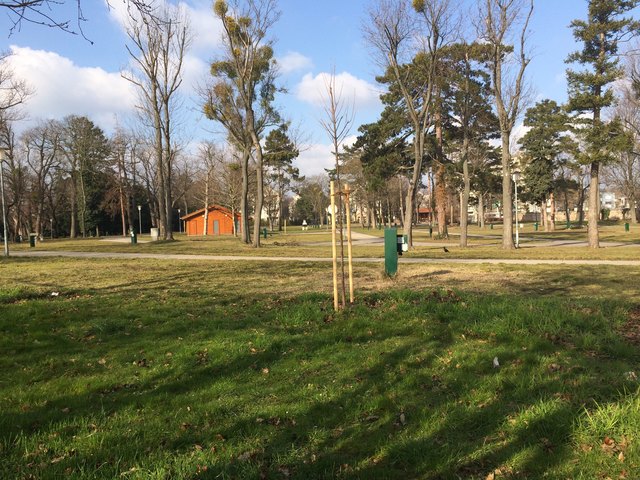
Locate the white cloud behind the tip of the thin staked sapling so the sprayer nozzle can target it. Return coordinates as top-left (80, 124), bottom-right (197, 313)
top-left (295, 72), bottom-right (380, 109)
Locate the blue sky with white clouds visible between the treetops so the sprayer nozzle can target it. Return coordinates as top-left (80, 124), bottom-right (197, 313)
top-left (0, 0), bottom-right (620, 175)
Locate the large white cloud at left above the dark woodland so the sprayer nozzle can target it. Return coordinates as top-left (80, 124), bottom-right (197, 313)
top-left (10, 46), bottom-right (136, 130)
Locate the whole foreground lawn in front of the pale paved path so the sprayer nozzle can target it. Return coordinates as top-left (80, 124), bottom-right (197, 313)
top-left (0, 260), bottom-right (640, 479)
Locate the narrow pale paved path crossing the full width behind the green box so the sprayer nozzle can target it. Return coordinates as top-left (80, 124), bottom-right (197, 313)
top-left (11, 250), bottom-right (640, 266)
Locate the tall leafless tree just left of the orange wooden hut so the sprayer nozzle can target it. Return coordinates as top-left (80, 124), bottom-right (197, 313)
top-left (122, 0), bottom-right (190, 240)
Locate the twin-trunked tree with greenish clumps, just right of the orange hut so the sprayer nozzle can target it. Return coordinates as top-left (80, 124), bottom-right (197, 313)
top-left (205, 0), bottom-right (280, 247)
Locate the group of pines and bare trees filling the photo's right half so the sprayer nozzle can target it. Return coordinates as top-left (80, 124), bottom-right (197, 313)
top-left (345, 0), bottom-right (639, 249)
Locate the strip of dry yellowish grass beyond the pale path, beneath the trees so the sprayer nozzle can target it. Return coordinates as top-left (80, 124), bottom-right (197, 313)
top-left (11, 223), bottom-right (640, 260)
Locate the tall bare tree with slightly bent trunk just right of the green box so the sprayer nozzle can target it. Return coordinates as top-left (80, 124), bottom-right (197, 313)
top-left (363, 0), bottom-right (453, 245)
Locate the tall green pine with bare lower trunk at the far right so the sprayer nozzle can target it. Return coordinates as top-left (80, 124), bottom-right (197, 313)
top-left (567, 0), bottom-right (640, 248)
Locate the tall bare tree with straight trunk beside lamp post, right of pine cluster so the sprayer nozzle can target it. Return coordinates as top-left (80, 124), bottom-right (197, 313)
top-left (476, 0), bottom-right (533, 250)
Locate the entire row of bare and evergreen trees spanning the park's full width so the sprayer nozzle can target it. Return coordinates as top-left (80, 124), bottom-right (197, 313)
top-left (0, 0), bottom-right (640, 249)
